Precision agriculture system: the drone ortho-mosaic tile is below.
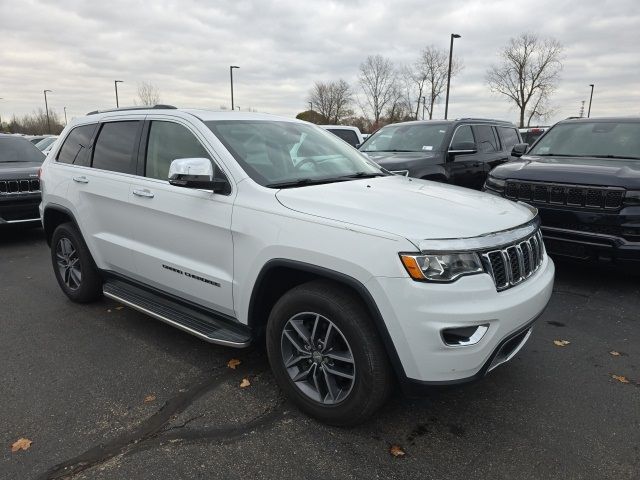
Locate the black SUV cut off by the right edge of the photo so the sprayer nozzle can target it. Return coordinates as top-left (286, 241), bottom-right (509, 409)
top-left (485, 118), bottom-right (640, 266)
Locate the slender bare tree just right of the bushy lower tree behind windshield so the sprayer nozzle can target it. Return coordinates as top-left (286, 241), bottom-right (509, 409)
top-left (359, 55), bottom-right (398, 126)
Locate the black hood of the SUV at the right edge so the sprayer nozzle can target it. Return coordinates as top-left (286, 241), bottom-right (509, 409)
top-left (491, 156), bottom-right (640, 190)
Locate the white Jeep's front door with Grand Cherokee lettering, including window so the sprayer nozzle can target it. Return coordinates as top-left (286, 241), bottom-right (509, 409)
top-left (128, 116), bottom-right (235, 316)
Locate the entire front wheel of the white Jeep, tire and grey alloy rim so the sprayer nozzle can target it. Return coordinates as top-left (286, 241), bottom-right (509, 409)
top-left (266, 280), bottom-right (393, 426)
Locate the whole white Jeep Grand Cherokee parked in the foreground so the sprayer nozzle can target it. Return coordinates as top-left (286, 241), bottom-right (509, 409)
top-left (40, 106), bottom-right (554, 425)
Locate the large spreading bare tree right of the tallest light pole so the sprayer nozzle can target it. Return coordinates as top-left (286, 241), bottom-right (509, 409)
top-left (486, 33), bottom-right (563, 127)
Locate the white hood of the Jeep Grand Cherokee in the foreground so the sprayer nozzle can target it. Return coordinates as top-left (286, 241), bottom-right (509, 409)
top-left (276, 175), bottom-right (534, 245)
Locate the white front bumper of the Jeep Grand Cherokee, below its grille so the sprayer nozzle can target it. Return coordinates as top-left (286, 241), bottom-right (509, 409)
top-left (367, 257), bottom-right (555, 391)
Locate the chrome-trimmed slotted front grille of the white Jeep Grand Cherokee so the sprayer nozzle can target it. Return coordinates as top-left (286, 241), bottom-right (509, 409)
top-left (481, 230), bottom-right (544, 291)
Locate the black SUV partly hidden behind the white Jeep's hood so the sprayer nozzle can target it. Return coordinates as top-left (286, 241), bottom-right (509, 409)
top-left (360, 118), bottom-right (522, 190)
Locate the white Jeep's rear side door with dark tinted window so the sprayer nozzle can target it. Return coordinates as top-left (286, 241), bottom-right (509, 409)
top-left (59, 118), bottom-right (143, 276)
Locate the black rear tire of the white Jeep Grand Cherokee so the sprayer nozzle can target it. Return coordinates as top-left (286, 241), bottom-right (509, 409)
top-left (51, 223), bottom-right (102, 303)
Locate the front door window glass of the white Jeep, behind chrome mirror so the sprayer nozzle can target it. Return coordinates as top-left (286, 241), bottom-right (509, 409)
top-left (145, 121), bottom-right (219, 180)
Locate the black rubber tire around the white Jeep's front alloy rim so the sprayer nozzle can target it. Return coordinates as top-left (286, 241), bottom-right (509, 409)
top-left (266, 280), bottom-right (394, 426)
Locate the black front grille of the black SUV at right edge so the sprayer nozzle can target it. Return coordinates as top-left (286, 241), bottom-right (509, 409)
top-left (505, 180), bottom-right (625, 210)
